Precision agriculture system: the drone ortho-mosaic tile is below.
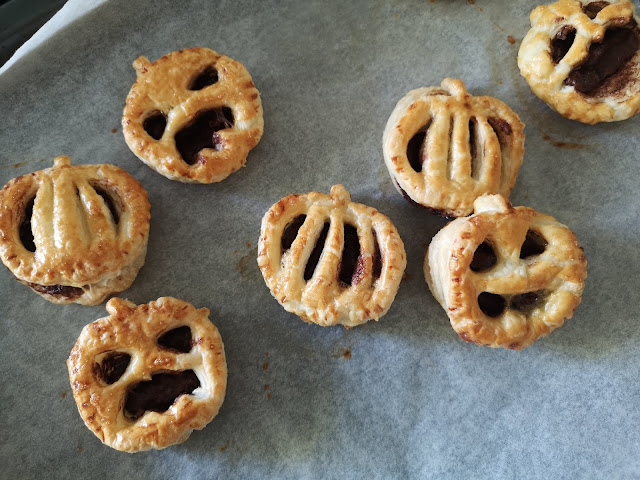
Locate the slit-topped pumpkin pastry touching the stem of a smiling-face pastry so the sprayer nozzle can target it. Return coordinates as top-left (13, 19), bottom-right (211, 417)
top-left (382, 78), bottom-right (524, 217)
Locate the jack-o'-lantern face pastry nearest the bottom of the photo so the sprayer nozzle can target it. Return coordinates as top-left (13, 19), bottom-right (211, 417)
top-left (67, 297), bottom-right (227, 452)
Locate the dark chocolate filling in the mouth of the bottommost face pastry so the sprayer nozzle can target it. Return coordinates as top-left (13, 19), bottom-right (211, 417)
top-left (124, 370), bottom-right (200, 420)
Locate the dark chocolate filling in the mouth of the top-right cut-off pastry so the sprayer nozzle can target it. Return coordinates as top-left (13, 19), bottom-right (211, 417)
top-left (565, 20), bottom-right (640, 94)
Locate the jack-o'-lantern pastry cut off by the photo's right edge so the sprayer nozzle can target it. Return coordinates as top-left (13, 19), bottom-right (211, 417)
top-left (518, 0), bottom-right (640, 124)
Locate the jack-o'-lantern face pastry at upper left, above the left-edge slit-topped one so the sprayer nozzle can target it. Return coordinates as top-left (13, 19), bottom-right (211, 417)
top-left (122, 48), bottom-right (264, 183)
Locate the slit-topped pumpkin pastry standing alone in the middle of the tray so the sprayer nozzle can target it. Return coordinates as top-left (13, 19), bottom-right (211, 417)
top-left (258, 185), bottom-right (407, 327)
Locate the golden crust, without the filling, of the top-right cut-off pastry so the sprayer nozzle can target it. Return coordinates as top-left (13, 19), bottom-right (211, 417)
top-left (518, 0), bottom-right (640, 124)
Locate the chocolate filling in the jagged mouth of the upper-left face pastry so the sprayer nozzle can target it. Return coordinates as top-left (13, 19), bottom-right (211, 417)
top-left (175, 107), bottom-right (233, 165)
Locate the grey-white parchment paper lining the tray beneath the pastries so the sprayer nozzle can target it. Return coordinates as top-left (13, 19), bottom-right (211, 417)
top-left (0, 0), bottom-right (640, 479)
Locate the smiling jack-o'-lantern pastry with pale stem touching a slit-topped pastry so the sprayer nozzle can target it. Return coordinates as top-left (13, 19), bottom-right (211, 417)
top-left (424, 195), bottom-right (587, 350)
